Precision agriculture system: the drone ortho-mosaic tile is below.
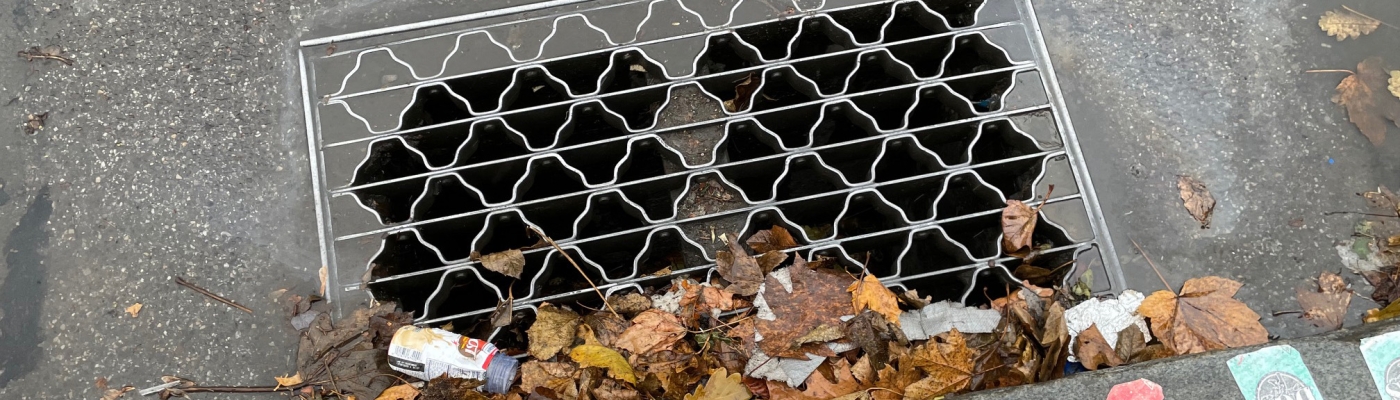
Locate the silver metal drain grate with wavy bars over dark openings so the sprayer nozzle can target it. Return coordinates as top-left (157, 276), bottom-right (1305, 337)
top-left (301, 0), bottom-right (1121, 334)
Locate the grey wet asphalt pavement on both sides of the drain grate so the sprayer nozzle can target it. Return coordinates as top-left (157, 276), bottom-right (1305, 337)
top-left (0, 0), bottom-right (1400, 399)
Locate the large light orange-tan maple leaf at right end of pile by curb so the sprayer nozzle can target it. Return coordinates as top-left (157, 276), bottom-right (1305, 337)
top-left (1138, 277), bottom-right (1268, 354)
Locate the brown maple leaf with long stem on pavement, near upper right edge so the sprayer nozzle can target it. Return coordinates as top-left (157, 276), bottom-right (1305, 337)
top-left (1331, 57), bottom-right (1400, 145)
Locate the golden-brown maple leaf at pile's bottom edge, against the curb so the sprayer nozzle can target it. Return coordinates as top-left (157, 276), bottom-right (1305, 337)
top-left (900, 329), bottom-right (977, 399)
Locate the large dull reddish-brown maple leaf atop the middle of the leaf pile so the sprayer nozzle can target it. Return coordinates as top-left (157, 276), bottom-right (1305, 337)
top-left (755, 256), bottom-right (853, 358)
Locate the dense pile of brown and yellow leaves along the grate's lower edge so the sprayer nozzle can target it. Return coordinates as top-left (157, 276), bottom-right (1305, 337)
top-left (379, 222), bottom-right (1267, 400)
